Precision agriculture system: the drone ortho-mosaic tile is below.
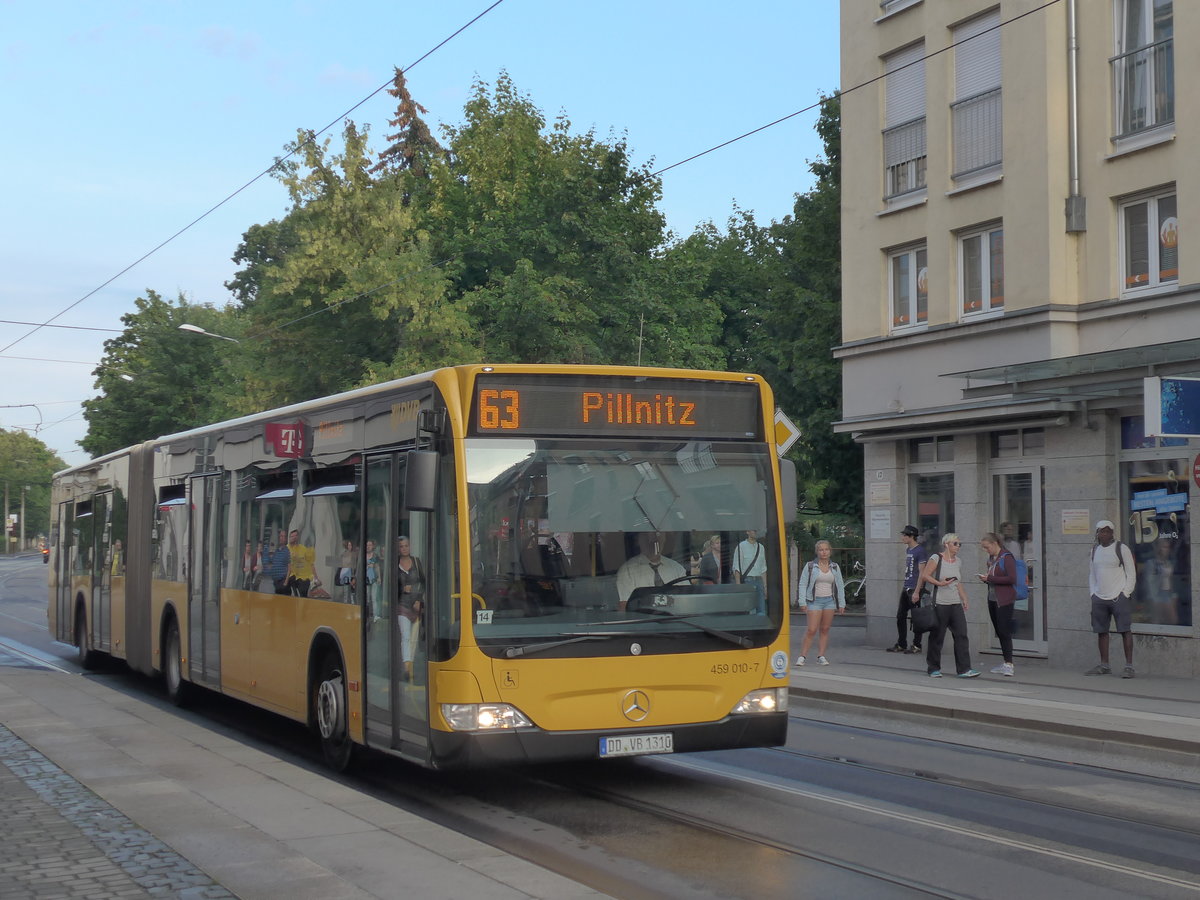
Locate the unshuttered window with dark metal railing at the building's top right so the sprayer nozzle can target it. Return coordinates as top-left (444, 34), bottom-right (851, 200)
top-left (1111, 0), bottom-right (1175, 137)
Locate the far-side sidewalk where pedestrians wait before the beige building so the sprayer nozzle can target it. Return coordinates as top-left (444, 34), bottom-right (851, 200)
top-left (791, 616), bottom-right (1200, 773)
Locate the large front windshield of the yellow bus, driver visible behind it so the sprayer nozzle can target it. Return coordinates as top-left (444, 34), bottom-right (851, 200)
top-left (466, 438), bottom-right (782, 655)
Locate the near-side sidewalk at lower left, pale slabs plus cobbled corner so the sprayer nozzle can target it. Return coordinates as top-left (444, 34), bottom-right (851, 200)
top-left (0, 653), bottom-right (604, 900)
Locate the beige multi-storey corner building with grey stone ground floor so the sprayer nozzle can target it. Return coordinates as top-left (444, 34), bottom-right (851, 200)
top-left (835, 0), bottom-right (1200, 676)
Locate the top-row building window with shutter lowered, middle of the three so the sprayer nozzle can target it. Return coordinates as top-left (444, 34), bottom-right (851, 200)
top-left (950, 10), bottom-right (1003, 179)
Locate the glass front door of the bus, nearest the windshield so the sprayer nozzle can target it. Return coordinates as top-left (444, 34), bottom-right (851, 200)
top-left (362, 454), bottom-right (428, 760)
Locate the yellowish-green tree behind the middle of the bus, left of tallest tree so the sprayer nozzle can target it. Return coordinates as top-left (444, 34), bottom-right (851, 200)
top-left (229, 122), bottom-right (473, 412)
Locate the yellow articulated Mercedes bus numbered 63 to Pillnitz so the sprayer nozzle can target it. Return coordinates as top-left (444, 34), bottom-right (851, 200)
top-left (49, 365), bottom-right (796, 768)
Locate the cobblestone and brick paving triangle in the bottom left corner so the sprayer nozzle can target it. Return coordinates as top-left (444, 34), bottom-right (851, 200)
top-left (0, 725), bottom-right (234, 900)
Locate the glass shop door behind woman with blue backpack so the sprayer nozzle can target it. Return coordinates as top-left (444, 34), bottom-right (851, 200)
top-left (991, 467), bottom-right (1046, 653)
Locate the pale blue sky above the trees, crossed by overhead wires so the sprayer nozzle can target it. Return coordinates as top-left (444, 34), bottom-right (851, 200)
top-left (0, 0), bottom-right (839, 464)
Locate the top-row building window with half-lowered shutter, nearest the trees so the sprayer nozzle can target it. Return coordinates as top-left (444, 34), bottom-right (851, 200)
top-left (883, 43), bottom-right (925, 199)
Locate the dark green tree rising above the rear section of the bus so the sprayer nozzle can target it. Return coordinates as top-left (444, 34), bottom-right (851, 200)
top-left (79, 290), bottom-right (239, 456)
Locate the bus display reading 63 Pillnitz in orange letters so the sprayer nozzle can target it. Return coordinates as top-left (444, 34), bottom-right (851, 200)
top-left (472, 374), bottom-right (762, 440)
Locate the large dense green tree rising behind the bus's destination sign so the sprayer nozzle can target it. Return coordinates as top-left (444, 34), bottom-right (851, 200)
top-left (422, 73), bottom-right (720, 365)
